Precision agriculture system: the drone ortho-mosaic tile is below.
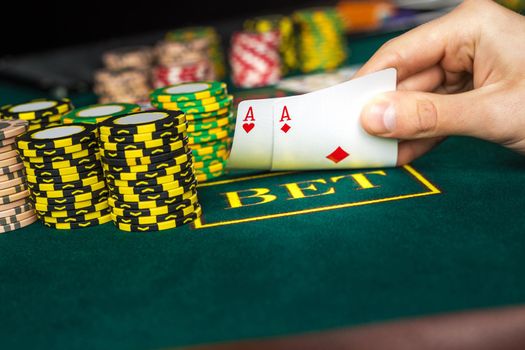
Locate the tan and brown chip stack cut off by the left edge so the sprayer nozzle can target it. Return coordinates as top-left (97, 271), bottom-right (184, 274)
top-left (0, 120), bottom-right (37, 233)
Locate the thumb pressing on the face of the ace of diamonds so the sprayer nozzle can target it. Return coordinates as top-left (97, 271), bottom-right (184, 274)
top-left (361, 91), bottom-right (486, 139)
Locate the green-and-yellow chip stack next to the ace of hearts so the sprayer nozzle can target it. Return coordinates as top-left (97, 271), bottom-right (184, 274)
top-left (150, 82), bottom-right (235, 182)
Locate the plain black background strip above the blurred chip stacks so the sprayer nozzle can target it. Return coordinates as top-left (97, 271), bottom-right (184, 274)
top-left (0, 0), bottom-right (328, 57)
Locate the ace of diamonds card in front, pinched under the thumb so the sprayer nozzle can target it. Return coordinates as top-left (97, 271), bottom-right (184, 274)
top-left (271, 69), bottom-right (397, 170)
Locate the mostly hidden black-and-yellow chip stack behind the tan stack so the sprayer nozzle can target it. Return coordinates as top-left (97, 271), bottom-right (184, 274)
top-left (0, 98), bottom-right (73, 131)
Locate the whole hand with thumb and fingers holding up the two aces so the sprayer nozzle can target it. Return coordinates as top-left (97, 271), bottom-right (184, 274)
top-left (355, 0), bottom-right (525, 165)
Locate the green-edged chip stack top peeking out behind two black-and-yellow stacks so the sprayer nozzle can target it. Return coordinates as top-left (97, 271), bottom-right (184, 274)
top-left (62, 103), bottom-right (140, 124)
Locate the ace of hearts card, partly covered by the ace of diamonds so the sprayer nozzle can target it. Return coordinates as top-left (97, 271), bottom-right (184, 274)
top-left (227, 98), bottom-right (278, 170)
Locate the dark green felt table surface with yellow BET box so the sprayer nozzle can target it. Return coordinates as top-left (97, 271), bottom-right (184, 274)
top-left (0, 30), bottom-right (525, 349)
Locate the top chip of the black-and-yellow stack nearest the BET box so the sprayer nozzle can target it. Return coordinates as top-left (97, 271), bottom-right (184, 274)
top-left (99, 111), bottom-right (186, 136)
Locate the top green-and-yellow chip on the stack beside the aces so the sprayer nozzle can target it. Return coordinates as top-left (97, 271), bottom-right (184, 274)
top-left (150, 81), bottom-right (226, 103)
